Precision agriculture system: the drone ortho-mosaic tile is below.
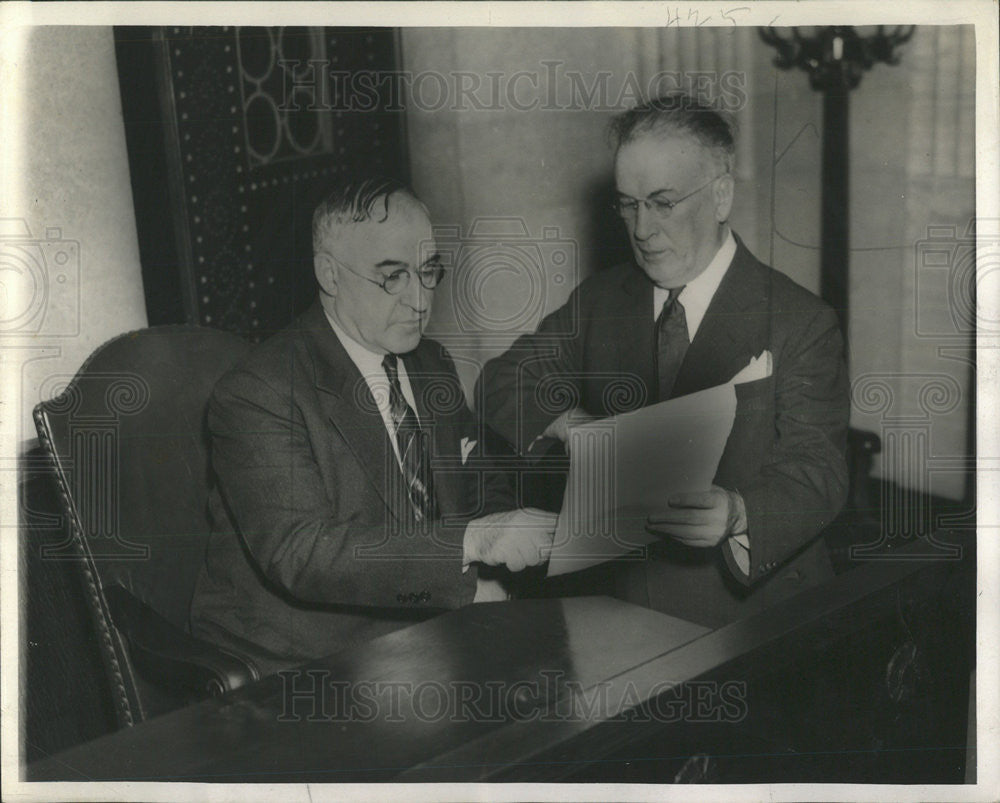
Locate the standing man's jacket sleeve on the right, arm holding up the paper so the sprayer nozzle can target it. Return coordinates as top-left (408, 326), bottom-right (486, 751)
top-left (723, 308), bottom-right (850, 585)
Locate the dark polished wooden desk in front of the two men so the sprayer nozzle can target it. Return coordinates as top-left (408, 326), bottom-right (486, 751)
top-left (27, 540), bottom-right (975, 782)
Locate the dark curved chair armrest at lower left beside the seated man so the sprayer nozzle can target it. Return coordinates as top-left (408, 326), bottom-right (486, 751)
top-left (104, 584), bottom-right (260, 696)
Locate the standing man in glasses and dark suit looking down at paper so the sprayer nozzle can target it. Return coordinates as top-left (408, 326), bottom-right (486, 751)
top-left (476, 94), bottom-right (849, 627)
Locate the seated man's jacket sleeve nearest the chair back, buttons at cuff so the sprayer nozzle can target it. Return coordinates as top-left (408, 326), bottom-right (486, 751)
top-left (208, 369), bottom-right (477, 608)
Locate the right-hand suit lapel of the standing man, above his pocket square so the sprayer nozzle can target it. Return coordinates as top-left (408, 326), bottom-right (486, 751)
top-left (671, 239), bottom-right (770, 398)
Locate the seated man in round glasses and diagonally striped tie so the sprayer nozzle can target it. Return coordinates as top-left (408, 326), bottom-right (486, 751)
top-left (191, 179), bottom-right (555, 674)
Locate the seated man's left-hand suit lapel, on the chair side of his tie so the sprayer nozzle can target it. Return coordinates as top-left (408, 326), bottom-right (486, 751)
top-left (303, 301), bottom-right (409, 521)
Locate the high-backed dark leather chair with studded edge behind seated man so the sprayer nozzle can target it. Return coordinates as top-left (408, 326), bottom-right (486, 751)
top-left (34, 326), bottom-right (258, 726)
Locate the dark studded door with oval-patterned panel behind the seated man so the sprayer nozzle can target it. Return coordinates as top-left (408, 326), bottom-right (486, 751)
top-left (115, 27), bottom-right (407, 339)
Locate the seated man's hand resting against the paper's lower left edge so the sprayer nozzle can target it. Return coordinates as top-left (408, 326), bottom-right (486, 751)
top-left (465, 507), bottom-right (558, 572)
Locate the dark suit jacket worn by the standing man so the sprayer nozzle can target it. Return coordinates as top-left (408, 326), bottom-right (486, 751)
top-left (476, 238), bottom-right (849, 626)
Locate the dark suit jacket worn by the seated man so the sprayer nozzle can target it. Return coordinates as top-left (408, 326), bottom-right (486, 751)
top-left (192, 303), bottom-right (514, 674)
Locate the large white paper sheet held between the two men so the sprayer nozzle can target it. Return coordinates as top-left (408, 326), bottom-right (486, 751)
top-left (548, 384), bottom-right (736, 577)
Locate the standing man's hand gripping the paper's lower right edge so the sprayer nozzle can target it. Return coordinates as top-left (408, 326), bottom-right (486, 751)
top-left (646, 485), bottom-right (747, 547)
